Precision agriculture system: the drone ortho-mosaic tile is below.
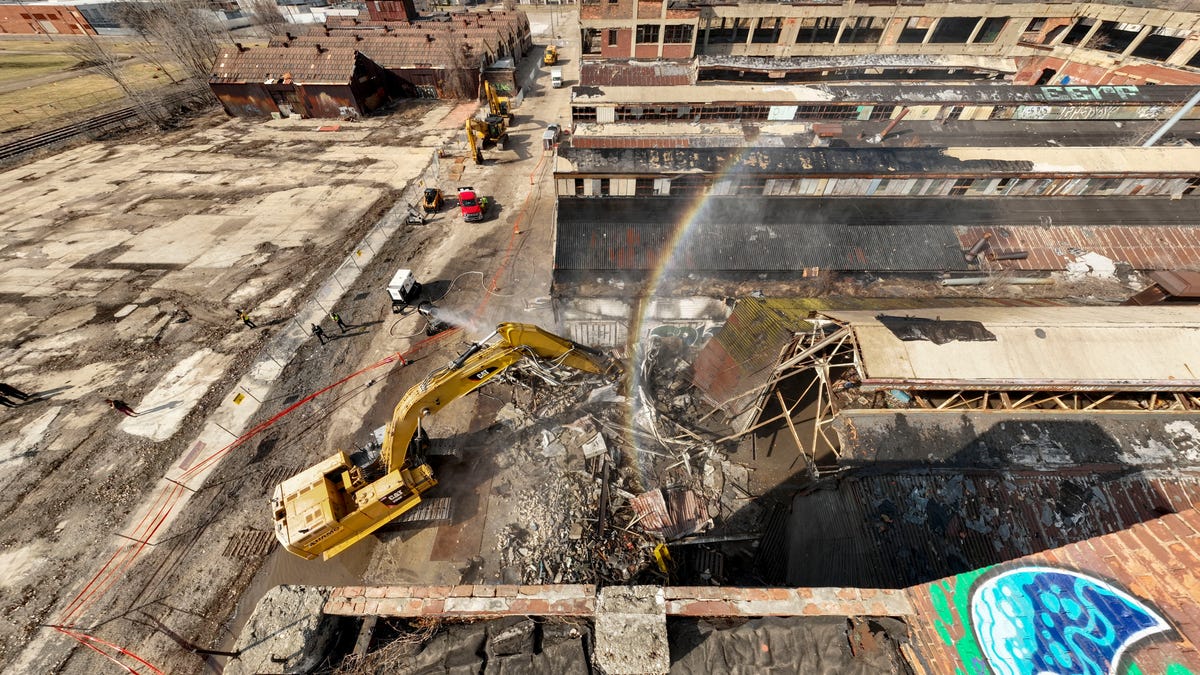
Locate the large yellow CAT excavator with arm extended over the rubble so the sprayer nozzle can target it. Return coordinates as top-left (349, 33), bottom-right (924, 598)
top-left (271, 323), bottom-right (623, 560)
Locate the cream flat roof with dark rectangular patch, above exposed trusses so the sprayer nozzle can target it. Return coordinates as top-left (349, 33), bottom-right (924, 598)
top-left (822, 306), bottom-right (1200, 389)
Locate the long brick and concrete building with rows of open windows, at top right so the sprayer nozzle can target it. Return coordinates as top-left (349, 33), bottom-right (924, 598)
top-left (580, 0), bottom-right (1200, 84)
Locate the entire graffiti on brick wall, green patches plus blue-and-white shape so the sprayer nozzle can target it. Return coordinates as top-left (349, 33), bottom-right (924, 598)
top-left (930, 567), bottom-right (1192, 675)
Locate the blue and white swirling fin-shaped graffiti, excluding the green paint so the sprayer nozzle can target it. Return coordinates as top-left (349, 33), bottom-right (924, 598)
top-left (971, 567), bottom-right (1170, 675)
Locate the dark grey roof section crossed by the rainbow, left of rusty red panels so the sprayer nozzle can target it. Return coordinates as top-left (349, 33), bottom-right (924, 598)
top-left (554, 197), bottom-right (966, 273)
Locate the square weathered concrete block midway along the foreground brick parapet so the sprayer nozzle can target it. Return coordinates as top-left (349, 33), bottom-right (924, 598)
top-left (595, 586), bottom-right (671, 675)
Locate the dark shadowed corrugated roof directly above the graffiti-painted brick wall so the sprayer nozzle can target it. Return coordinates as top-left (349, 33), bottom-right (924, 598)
top-left (787, 472), bottom-right (1200, 589)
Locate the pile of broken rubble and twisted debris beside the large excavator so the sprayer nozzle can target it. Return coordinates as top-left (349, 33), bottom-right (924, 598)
top-left (484, 336), bottom-right (748, 584)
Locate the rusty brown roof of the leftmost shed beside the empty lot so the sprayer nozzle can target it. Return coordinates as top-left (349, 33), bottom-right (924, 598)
top-left (210, 47), bottom-right (358, 84)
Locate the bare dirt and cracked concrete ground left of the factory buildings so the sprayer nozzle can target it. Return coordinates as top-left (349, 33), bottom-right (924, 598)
top-left (0, 11), bottom-right (577, 673)
